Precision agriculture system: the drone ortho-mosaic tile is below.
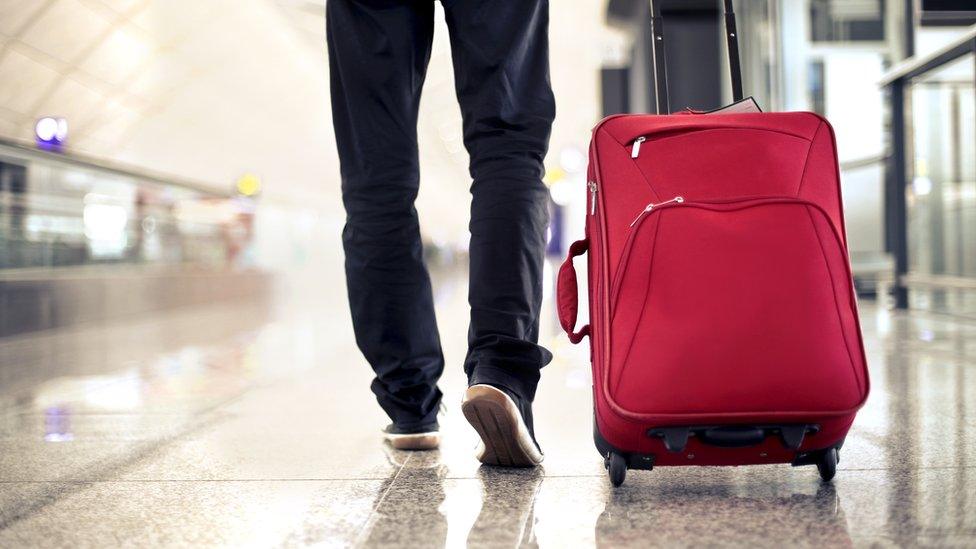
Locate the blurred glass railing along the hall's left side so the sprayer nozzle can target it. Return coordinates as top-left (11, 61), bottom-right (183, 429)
top-left (0, 143), bottom-right (253, 273)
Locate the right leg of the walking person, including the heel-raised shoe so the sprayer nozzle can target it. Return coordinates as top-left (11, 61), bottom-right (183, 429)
top-left (444, 0), bottom-right (555, 465)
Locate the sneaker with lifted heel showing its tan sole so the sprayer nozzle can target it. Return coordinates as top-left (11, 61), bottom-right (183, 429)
top-left (461, 385), bottom-right (543, 467)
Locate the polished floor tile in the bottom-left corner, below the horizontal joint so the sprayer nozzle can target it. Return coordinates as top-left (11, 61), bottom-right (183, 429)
top-left (0, 481), bottom-right (385, 547)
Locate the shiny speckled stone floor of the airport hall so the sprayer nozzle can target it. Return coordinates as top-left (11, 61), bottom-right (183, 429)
top-left (0, 264), bottom-right (976, 548)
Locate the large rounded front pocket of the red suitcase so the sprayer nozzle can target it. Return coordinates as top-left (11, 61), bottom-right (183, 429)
top-left (604, 197), bottom-right (866, 416)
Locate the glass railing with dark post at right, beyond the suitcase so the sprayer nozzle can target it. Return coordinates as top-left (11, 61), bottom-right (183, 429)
top-left (880, 26), bottom-right (976, 312)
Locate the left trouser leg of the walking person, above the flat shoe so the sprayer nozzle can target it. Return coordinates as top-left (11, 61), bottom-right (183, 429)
top-left (327, 0), bottom-right (444, 436)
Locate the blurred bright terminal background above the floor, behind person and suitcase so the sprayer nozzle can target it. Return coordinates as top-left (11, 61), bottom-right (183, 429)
top-left (0, 0), bottom-right (976, 336)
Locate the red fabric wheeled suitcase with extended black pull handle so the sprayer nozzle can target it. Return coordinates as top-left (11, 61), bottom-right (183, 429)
top-left (557, 1), bottom-right (868, 486)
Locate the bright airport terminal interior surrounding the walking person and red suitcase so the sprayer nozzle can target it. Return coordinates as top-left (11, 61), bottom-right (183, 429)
top-left (0, 0), bottom-right (976, 548)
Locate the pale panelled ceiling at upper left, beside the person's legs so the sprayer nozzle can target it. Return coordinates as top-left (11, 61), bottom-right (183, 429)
top-left (0, 0), bottom-right (344, 210)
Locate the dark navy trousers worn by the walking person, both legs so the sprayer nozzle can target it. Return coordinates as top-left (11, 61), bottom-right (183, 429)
top-left (327, 0), bottom-right (555, 426)
